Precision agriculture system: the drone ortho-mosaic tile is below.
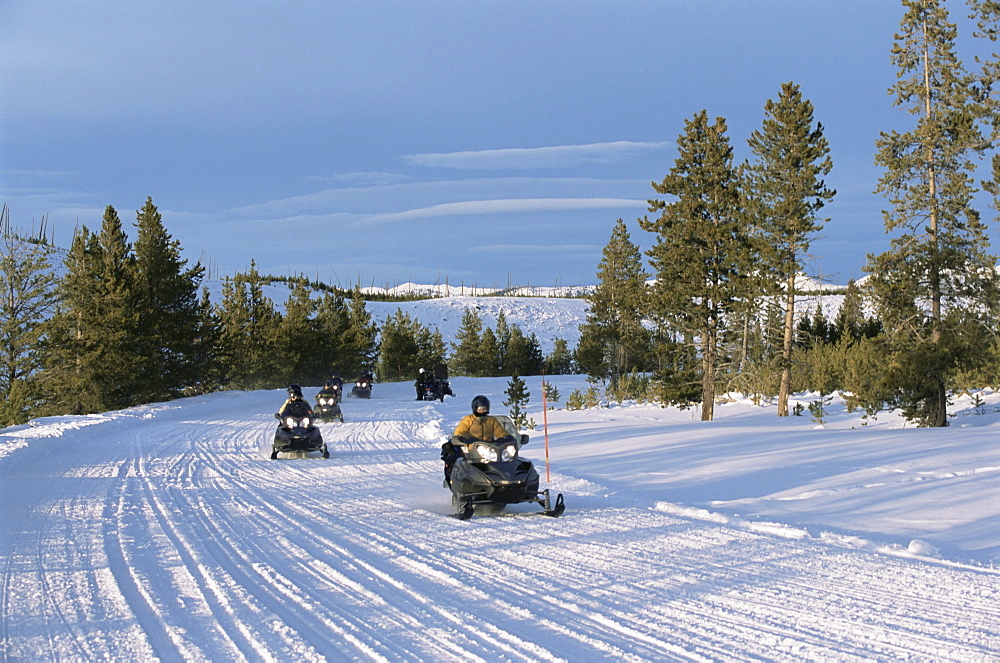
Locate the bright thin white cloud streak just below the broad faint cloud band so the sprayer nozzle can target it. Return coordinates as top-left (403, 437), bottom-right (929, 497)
top-left (358, 198), bottom-right (649, 225)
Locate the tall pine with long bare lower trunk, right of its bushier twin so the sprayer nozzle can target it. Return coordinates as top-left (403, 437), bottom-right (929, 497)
top-left (746, 82), bottom-right (836, 417)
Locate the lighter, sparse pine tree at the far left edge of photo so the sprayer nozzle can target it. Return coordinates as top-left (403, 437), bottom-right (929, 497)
top-left (0, 205), bottom-right (58, 428)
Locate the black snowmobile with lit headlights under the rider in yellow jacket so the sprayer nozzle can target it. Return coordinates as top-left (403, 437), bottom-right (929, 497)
top-left (449, 415), bottom-right (566, 520)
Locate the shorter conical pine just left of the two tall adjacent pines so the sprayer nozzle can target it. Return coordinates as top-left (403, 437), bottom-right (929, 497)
top-left (579, 219), bottom-right (651, 385)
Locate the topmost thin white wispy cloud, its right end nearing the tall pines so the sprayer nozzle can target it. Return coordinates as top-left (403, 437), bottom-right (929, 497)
top-left (403, 140), bottom-right (673, 170)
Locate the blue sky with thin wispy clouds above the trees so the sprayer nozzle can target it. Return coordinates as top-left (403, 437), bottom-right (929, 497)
top-left (0, 0), bottom-right (992, 287)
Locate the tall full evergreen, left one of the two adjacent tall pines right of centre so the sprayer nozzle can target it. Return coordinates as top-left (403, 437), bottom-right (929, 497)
top-left (640, 110), bottom-right (751, 421)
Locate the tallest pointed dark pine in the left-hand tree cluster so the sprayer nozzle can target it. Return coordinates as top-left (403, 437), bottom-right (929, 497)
top-left (133, 198), bottom-right (205, 403)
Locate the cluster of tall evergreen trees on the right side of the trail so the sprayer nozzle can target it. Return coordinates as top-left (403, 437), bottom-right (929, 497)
top-left (578, 0), bottom-right (1000, 426)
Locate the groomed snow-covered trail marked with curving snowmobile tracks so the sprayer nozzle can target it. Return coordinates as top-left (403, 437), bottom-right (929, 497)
top-left (0, 384), bottom-right (1000, 661)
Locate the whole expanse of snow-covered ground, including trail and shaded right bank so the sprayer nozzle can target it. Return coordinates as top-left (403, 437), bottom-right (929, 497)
top-left (0, 376), bottom-right (1000, 661)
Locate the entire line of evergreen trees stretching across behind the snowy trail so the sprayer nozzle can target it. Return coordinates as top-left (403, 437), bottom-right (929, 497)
top-left (0, 0), bottom-right (1000, 426)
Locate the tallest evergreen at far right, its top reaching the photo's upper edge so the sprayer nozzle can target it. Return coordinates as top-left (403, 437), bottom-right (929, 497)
top-left (865, 0), bottom-right (997, 426)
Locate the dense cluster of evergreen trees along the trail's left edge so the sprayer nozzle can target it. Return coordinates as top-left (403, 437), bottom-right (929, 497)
top-left (0, 199), bottom-right (378, 425)
